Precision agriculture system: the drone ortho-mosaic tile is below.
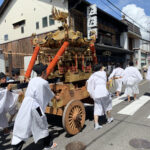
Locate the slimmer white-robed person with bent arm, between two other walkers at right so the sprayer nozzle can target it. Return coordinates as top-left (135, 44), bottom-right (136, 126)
top-left (108, 63), bottom-right (124, 97)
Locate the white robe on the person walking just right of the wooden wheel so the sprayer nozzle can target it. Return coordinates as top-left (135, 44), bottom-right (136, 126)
top-left (87, 71), bottom-right (112, 116)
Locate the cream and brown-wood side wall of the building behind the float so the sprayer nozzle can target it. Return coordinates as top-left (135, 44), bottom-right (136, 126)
top-left (0, 0), bottom-right (68, 73)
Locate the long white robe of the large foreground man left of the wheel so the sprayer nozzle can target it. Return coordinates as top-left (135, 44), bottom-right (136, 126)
top-left (12, 77), bottom-right (54, 145)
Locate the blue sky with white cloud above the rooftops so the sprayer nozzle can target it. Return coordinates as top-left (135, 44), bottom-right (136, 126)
top-left (0, 0), bottom-right (150, 40)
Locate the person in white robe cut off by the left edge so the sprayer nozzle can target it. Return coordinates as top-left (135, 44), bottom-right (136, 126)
top-left (0, 72), bottom-right (19, 134)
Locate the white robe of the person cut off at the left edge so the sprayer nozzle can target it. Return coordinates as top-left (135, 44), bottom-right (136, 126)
top-left (0, 88), bottom-right (19, 128)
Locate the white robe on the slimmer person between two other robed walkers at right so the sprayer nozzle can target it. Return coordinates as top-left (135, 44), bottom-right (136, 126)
top-left (108, 67), bottom-right (124, 92)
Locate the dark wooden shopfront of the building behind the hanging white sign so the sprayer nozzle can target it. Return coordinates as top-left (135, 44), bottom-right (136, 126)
top-left (69, 0), bottom-right (131, 65)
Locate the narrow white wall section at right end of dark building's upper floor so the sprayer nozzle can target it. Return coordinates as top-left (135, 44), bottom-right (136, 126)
top-left (120, 32), bottom-right (128, 49)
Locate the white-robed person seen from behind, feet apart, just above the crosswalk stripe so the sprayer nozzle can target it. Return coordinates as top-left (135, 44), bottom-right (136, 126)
top-left (123, 62), bottom-right (143, 102)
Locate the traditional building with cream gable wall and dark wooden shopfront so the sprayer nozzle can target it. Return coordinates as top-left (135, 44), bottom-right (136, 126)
top-left (0, 0), bottom-right (138, 74)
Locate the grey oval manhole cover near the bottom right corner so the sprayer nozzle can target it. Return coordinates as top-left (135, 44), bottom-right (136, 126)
top-left (129, 138), bottom-right (150, 149)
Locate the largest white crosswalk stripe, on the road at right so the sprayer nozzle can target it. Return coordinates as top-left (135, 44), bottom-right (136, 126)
top-left (118, 95), bottom-right (150, 116)
